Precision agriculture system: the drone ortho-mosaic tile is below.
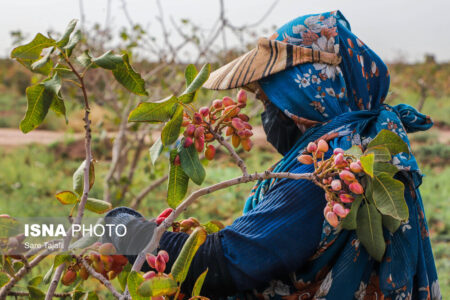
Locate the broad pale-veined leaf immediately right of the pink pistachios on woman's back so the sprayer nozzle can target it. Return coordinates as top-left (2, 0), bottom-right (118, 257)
top-left (373, 173), bottom-right (409, 220)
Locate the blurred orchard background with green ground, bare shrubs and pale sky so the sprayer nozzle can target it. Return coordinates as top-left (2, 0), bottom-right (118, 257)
top-left (0, 0), bottom-right (450, 295)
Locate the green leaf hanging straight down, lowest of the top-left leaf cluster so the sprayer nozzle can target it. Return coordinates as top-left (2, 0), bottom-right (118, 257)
top-left (20, 84), bottom-right (54, 133)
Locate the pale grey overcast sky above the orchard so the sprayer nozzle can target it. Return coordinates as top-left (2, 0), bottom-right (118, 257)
top-left (0, 0), bottom-right (450, 62)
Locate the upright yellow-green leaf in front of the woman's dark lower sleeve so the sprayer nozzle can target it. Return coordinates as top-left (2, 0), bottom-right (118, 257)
top-left (172, 227), bottom-right (206, 284)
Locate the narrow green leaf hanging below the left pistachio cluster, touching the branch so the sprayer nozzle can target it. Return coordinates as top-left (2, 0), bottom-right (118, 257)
top-left (167, 149), bottom-right (189, 208)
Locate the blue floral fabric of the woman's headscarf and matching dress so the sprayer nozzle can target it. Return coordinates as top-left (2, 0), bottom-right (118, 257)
top-left (244, 11), bottom-right (441, 299)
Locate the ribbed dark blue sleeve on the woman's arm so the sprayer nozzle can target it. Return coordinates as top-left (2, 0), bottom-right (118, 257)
top-left (220, 164), bottom-right (326, 290)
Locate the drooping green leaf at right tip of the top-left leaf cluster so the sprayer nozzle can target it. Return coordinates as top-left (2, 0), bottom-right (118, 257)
top-left (112, 54), bottom-right (148, 96)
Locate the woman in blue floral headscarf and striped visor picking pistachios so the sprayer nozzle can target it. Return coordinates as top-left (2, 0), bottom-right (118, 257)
top-left (103, 11), bottom-right (441, 299)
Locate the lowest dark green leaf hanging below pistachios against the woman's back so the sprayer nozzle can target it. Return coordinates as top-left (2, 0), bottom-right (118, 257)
top-left (356, 203), bottom-right (386, 261)
